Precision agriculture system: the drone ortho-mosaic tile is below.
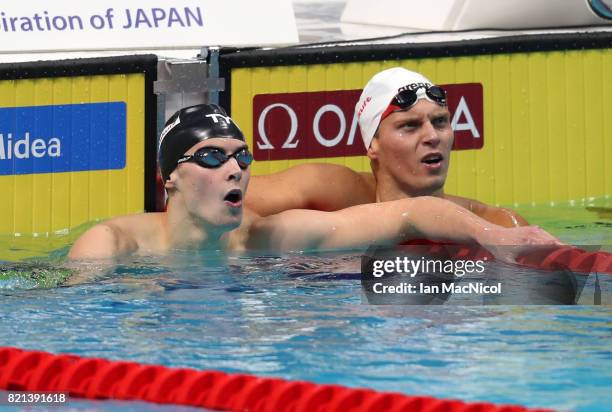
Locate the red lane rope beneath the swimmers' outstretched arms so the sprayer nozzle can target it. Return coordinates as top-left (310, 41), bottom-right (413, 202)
top-left (399, 239), bottom-right (612, 275)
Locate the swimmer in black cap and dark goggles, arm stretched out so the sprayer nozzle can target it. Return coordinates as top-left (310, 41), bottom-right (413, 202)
top-left (68, 104), bottom-right (554, 260)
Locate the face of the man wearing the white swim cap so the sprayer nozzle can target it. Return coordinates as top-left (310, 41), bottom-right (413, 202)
top-left (368, 99), bottom-right (453, 196)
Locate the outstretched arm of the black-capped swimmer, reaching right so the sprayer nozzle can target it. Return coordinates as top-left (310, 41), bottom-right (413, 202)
top-left (249, 197), bottom-right (559, 260)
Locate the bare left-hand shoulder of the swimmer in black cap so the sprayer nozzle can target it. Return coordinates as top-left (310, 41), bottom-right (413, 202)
top-left (68, 213), bottom-right (162, 260)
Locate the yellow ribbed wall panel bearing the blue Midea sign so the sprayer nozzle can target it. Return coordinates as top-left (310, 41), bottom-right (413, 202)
top-left (0, 74), bottom-right (145, 236)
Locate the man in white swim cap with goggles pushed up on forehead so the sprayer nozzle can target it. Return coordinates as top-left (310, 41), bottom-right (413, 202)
top-left (246, 67), bottom-right (527, 227)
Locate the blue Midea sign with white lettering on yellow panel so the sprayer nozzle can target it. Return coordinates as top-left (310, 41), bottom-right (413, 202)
top-left (0, 102), bottom-right (127, 175)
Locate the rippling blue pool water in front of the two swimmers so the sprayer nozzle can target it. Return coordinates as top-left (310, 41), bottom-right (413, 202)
top-left (0, 198), bottom-right (612, 411)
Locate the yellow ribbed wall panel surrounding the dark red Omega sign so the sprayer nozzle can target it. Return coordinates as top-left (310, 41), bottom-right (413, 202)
top-left (231, 49), bottom-right (612, 205)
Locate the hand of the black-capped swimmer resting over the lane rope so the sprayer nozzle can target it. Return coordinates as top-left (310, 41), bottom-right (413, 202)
top-left (476, 226), bottom-right (564, 263)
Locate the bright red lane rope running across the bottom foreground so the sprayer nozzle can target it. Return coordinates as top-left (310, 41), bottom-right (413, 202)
top-left (0, 347), bottom-right (556, 412)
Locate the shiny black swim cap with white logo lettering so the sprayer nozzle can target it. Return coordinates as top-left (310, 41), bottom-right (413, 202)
top-left (157, 104), bottom-right (245, 180)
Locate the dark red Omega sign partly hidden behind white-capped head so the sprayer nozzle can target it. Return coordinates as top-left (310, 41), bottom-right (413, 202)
top-left (253, 83), bottom-right (484, 160)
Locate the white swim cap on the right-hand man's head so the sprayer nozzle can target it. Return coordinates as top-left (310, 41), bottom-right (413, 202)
top-left (355, 67), bottom-right (433, 149)
